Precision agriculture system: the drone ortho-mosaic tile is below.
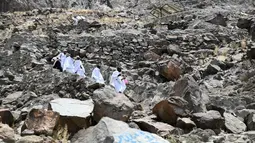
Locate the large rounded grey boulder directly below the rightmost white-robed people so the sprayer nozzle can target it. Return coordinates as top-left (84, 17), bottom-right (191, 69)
top-left (92, 86), bottom-right (134, 122)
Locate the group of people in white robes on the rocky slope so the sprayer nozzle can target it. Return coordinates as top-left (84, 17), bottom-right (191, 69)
top-left (52, 51), bottom-right (127, 93)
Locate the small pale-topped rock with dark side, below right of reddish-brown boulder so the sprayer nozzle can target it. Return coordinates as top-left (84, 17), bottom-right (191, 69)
top-left (176, 118), bottom-right (196, 130)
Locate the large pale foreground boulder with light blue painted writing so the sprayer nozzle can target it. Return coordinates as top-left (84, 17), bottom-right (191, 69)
top-left (71, 117), bottom-right (168, 143)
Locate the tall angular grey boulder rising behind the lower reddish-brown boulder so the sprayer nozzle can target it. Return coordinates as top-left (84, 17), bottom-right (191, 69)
top-left (173, 76), bottom-right (207, 113)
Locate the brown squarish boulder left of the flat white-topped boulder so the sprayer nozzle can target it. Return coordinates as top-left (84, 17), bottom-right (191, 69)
top-left (22, 109), bottom-right (59, 135)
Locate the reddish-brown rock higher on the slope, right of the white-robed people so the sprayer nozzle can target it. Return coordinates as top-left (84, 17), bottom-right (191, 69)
top-left (159, 61), bottom-right (181, 81)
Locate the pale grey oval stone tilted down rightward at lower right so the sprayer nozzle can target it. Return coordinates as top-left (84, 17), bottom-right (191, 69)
top-left (223, 113), bottom-right (247, 134)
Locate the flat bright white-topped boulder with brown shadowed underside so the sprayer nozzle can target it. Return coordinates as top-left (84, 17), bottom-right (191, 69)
top-left (49, 98), bottom-right (94, 132)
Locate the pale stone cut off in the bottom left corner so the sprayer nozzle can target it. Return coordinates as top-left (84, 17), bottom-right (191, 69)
top-left (0, 123), bottom-right (15, 143)
